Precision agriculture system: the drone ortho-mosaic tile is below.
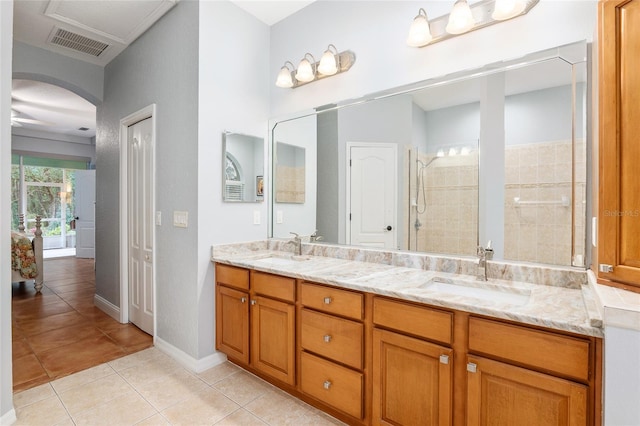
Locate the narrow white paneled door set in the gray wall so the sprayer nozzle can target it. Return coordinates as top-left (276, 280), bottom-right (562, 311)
top-left (127, 118), bottom-right (154, 335)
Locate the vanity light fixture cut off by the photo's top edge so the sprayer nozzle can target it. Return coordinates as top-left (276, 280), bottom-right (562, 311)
top-left (407, 0), bottom-right (539, 47)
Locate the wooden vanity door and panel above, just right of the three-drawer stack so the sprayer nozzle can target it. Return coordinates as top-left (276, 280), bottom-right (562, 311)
top-left (372, 297), bottom-right (454, 426)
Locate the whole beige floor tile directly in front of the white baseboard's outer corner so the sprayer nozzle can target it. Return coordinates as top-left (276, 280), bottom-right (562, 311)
top-left (134, 369), bottom-right (209, 411)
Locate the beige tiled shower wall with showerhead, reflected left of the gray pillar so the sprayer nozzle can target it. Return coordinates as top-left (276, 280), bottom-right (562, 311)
top-left (409, 151), bottom-right (478, 255)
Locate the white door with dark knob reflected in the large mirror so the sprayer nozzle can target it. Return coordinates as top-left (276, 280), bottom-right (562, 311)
top-left (347, 143), bottom-right (398, 249)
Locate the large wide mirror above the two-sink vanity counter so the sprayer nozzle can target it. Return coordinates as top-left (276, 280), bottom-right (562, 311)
top-left (271, 42), bottom-right (589, 267)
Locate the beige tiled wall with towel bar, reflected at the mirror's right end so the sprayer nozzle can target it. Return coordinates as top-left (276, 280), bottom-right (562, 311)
top-left (504, 140), bottom-right (586, 266)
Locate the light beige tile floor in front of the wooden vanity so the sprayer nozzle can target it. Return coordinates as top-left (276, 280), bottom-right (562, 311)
top-left (14, 348), bottom-right (342, 426)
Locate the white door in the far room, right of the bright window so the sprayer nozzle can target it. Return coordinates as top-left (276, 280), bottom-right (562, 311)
top-left (73, 170), bottom-right (96, 259)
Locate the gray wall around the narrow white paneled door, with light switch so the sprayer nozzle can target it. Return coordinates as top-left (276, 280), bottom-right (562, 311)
top-left (96, 1), bottom-right (199, 357)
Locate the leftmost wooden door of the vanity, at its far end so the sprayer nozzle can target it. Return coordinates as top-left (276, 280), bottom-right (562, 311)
top-left (216, 285), bottom-right (249, 364)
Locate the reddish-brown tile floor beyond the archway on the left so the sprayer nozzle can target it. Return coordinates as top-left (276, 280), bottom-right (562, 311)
top-left (11, 257), bottom-right (153, 391)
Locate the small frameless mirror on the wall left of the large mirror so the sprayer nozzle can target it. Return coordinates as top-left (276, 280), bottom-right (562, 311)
top-left (222, 132), bottom-right (265, 203)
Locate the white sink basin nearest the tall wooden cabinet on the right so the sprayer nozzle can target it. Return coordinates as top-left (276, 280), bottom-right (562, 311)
top-left (425, 278), bottom-right (531, 306)
